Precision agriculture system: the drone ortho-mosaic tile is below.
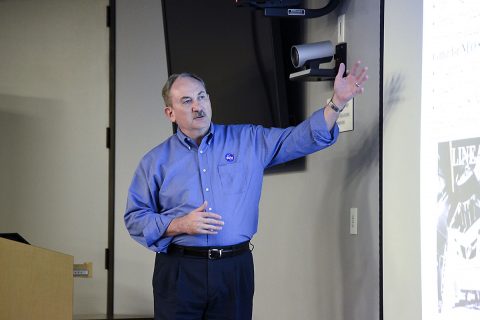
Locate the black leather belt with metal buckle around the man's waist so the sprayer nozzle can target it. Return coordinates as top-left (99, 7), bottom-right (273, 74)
top-left (167, 241), bottom-right (250, 260)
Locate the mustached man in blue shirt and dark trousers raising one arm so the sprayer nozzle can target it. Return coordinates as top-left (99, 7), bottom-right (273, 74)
top-left (125, 62), bottom-right (368, 320)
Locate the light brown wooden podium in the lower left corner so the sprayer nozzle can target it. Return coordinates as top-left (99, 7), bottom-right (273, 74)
top-left (0, 238), bottom-right (73, 320)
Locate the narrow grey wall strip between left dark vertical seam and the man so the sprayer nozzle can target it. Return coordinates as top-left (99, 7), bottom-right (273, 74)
top-left (114, 0), bottom-right (172, 315)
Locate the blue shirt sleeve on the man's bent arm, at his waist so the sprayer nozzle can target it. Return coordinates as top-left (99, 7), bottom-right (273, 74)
top-left (124, 161), bottom-right (177, 252)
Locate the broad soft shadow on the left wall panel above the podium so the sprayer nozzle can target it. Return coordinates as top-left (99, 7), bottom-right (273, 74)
top-left (0, 94), bottom-right (63, 238)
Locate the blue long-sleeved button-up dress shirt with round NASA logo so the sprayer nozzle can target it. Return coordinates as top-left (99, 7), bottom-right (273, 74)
top-left (124, 109), bottom-right (339, 252)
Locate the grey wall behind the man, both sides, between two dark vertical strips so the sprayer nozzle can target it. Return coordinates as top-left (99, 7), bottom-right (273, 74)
top-left (115, 0), bottom-right (380, 319)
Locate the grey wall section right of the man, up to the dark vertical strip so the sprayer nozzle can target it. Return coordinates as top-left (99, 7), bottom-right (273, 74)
top-left (254, 0), bottom-right (380, 319)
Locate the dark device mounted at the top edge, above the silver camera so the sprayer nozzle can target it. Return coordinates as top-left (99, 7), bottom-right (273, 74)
top-left (235, 0), bottom-right (341, 18)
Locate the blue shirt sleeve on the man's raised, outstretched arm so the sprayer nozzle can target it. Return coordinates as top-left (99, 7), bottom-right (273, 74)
top-left (256, 108), bottom-right (339, 168)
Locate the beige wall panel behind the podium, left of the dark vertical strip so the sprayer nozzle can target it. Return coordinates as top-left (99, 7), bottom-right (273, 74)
top-left (0, 0), bottom-right (108, 314)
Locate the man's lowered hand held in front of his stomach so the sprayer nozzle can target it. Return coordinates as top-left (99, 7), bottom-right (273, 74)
top-left (165, 201), bottom-right (224, 237)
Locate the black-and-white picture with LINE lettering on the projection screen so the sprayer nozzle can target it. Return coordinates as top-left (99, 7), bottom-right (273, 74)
top-left (437, 138), bottom-right (480, 313)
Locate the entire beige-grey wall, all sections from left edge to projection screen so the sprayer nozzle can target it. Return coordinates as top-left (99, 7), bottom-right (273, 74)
top-left (0, 0), bottom-right (428, 320)
